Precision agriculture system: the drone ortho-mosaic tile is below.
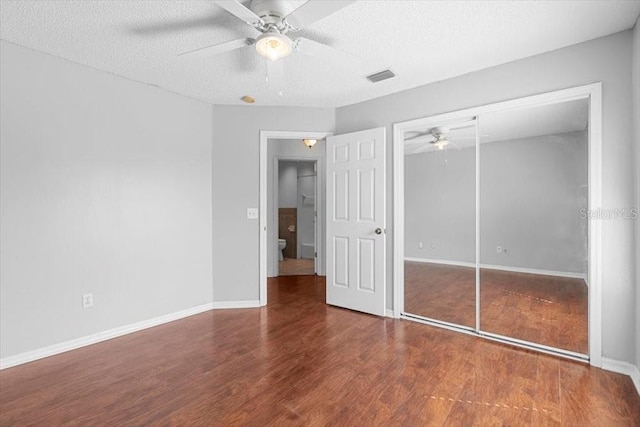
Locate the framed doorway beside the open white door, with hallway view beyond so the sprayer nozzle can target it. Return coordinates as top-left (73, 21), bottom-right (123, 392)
top-left (260, 131), bottom-right (326, 290)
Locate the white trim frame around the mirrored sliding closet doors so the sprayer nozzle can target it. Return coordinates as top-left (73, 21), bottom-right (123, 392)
top-left (392, 82), bottom-right (602, 367)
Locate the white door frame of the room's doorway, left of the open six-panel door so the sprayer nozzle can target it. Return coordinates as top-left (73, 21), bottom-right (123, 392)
top-left (258, 130), bottom-right (333, 307)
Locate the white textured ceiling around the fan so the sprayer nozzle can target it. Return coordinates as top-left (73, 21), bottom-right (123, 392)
top-left (0, 0), bottom-right (640, 107)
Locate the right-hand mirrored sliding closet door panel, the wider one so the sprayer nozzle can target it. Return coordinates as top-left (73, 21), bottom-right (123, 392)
top-left (479, 99), bottom-right (589, 354)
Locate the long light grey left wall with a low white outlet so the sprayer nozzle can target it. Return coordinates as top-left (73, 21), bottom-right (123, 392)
top-left (0, 42), bottom-right (213, 358)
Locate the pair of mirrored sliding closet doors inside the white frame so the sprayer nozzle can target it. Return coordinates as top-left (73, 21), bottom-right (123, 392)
top-left (396, 90), bottom-right (599, 360)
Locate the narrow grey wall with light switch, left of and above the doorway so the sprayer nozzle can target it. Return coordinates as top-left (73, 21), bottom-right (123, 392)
top-left (213, 106), bottom-right (335, 302)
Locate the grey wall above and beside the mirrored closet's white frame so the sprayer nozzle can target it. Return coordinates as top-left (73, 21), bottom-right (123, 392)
top-left (336, 31), bottom-right (637, 361)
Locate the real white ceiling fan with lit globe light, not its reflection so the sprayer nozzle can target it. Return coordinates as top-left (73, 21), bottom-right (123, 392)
top-left (179, 0), bottom-right (356, 61)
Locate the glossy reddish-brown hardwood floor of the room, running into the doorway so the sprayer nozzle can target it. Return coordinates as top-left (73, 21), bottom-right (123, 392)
top-left (0, 276), bottom-right (640, 427)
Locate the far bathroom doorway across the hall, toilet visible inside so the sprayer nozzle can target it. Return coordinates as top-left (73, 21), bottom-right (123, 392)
top-left (277, 159), bottom-right (318, 276)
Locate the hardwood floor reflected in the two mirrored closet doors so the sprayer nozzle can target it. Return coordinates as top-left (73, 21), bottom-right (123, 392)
top-left (405, 262), bottom-right (588, 354)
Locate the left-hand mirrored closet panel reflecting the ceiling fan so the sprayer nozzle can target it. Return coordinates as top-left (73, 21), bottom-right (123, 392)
top-left (404, 120), bottom-right (476, 328)
